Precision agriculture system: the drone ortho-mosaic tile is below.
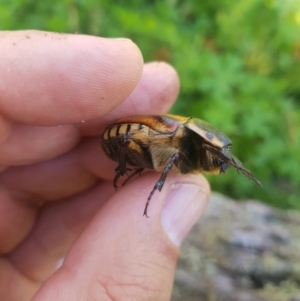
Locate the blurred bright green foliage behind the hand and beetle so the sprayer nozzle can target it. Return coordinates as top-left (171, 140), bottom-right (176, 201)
top-left (0, 0), bottom-right (300, 209)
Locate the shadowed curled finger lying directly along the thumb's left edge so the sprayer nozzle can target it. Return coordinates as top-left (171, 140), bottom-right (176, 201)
top-left (8, 182), bottom-right (115, 282)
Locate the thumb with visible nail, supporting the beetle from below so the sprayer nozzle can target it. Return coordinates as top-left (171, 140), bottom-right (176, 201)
top-left (33, 173), bottom-right (209, 301)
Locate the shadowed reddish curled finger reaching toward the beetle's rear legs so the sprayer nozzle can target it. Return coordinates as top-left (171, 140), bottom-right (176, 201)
top-left (0, 138), bottom-right (101, 202)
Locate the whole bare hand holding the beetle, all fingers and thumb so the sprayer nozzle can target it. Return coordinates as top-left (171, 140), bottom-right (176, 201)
top-left (0, 31), bottom-right (209, 301)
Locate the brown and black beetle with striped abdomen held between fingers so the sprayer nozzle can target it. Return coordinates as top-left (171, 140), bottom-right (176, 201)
top-left (101, 114), bottom-right (261, 217)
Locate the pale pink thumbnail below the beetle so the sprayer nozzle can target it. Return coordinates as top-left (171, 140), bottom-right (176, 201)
top-left (161, 184), bottom-right (208, 246)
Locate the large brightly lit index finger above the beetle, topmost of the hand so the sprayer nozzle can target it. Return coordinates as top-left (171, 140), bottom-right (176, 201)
top-left (0, 31), bottom-right (143, 125)
